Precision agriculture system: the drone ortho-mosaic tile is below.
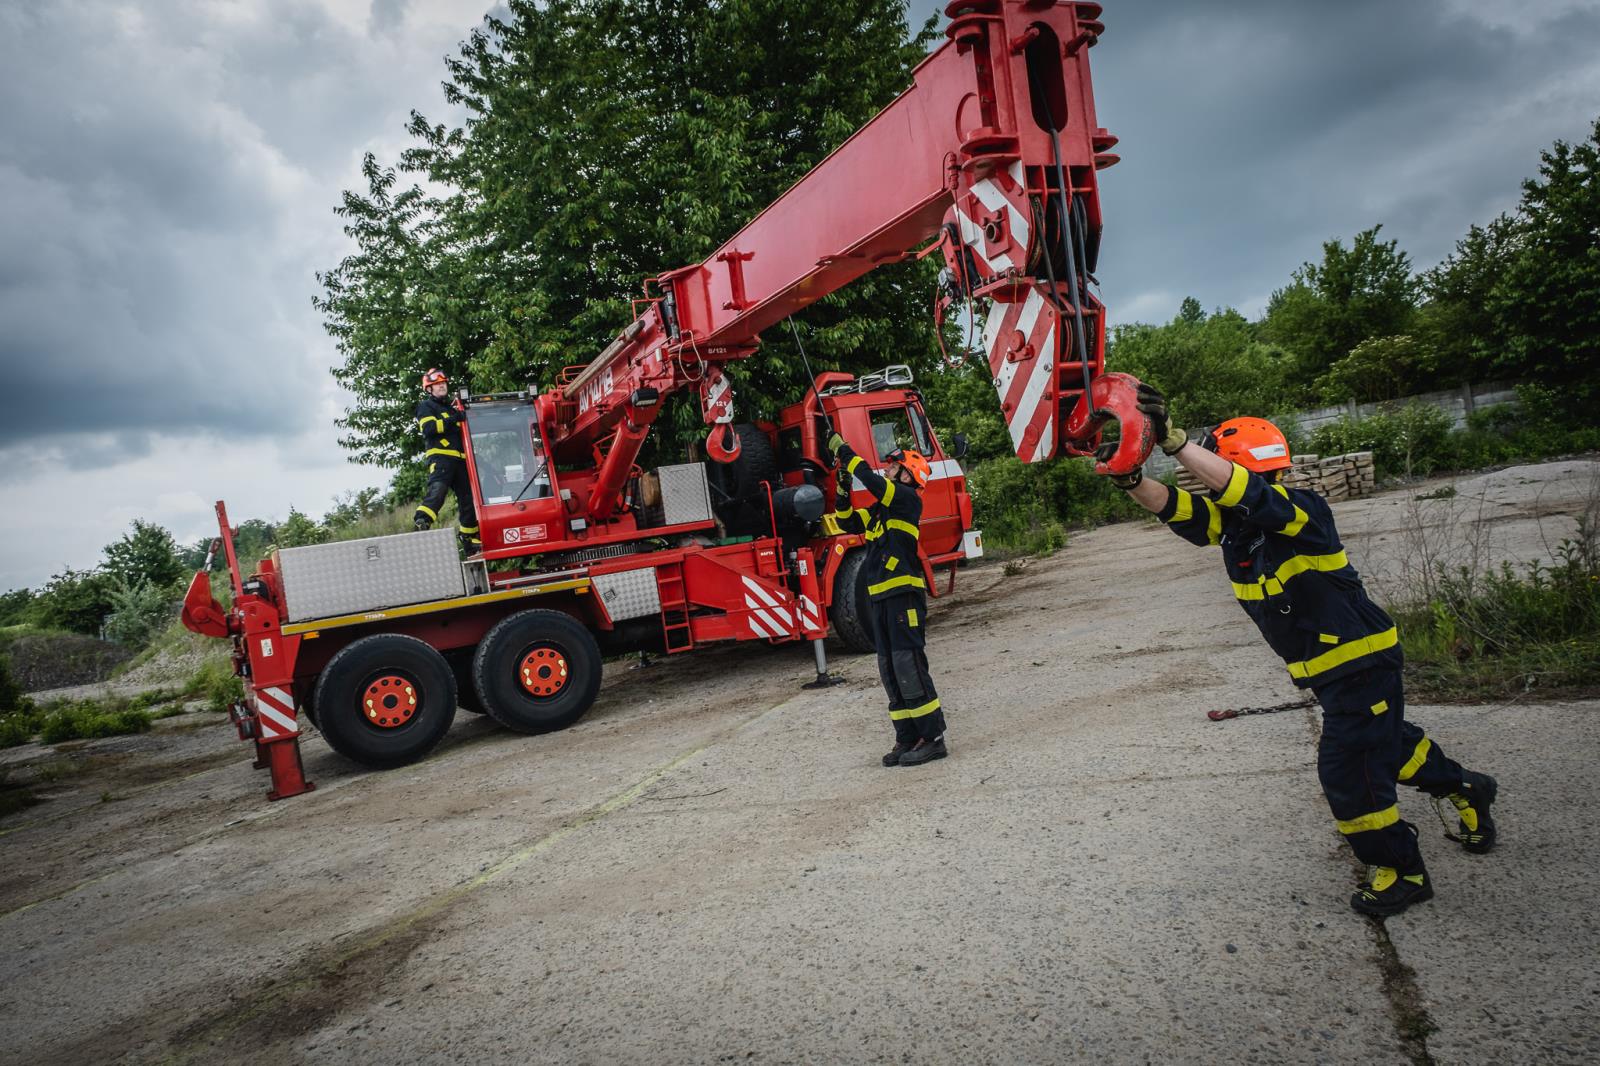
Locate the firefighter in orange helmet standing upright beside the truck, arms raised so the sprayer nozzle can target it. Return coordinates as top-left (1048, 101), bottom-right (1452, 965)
top-left (824, 432), bottom-right (949, 767)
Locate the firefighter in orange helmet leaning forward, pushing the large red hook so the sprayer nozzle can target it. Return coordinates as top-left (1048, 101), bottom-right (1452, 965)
top-left (1110, 384), bottom-right (1496, 916)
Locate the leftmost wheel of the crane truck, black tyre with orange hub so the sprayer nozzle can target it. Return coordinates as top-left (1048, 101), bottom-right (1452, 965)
top-left (314, 632), bottom-right (456, 770)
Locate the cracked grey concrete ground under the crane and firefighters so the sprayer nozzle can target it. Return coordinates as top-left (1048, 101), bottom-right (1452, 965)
top-left (0, 463), bottom-right (1600, 1063)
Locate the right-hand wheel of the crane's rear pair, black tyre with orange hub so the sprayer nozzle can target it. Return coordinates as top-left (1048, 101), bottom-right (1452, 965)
top-left (472, 610), bottom-right (600, 733)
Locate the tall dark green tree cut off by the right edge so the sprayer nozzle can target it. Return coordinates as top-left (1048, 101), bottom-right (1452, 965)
top-left (1485, 118), bottom-right (1600, 400)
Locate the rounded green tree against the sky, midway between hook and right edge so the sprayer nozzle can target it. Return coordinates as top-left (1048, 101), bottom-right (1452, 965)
top-left (1262, 226), bottom-right (1418, 392)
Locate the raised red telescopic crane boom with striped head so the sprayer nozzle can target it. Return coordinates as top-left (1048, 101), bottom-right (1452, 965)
top-left (552, 0), bottom-right (1117, 517)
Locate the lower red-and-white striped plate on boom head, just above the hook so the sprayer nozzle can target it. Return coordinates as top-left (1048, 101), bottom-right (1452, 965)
top-left (984, 288), bottom-right (1061, 463)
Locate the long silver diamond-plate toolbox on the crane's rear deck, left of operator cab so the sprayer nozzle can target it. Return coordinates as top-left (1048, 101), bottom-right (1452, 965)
top-left (278, 528), bottom-right (466, 623)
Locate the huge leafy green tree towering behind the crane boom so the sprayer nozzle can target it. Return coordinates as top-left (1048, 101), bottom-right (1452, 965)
top-left (317, 0), bottom-right (933, 466)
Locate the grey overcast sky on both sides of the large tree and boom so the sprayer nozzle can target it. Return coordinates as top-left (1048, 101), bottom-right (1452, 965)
top-left (0, 0), bottom-right (1600, 589)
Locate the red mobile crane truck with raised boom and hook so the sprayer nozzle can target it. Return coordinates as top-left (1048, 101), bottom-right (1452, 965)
top-left (182, 0), bottom-right (1150, 799)
